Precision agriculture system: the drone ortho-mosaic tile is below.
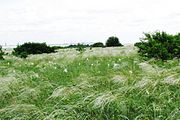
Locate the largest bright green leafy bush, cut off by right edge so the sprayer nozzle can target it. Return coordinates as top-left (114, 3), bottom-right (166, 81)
top-left (135, 32), bottom-right (180, 60)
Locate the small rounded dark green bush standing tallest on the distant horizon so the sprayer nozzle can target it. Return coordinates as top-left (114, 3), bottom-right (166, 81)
top-left (106, 36), bottom-right (123, 47)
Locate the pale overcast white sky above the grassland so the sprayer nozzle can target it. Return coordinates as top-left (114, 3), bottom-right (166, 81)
top-left (0, 0), bottom-right (180, 45)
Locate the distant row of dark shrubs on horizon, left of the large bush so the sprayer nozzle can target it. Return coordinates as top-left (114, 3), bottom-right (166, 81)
top-left (0, 37), bottom-right (123, 59)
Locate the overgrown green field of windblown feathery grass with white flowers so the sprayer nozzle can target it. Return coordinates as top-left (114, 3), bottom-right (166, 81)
top-left (0, 46), bottom-right (180, 120)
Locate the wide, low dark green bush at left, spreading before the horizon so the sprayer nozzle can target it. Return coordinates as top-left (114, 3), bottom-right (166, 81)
top-left (13, 42), bottom-right (55, 58)
